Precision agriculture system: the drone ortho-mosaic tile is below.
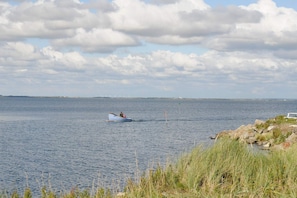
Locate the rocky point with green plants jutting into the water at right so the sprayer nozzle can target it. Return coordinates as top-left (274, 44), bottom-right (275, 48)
top-left (211, 115), bottom-right (297, 150)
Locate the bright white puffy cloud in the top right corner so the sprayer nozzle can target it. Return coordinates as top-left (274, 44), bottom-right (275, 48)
top-left (206, 0), bottom-right (297, 51)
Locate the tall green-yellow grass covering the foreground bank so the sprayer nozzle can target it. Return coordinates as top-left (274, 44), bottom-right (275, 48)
top-left (0, 138), bottom-right (297, 198)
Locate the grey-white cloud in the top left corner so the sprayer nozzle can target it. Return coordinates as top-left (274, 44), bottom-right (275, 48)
top-left (0, 0), bottom-right (109, 40)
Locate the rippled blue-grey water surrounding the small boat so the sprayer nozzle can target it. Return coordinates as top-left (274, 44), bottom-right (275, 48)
top-left (0, 97), bottom-right (297, 194)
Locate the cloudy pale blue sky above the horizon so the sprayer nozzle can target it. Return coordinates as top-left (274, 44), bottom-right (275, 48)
top-left (0, 0), bottom-right (297, 99)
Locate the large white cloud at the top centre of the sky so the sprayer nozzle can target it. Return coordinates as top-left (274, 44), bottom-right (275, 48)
top-left (110, 0), bottom-right (208, 36)
